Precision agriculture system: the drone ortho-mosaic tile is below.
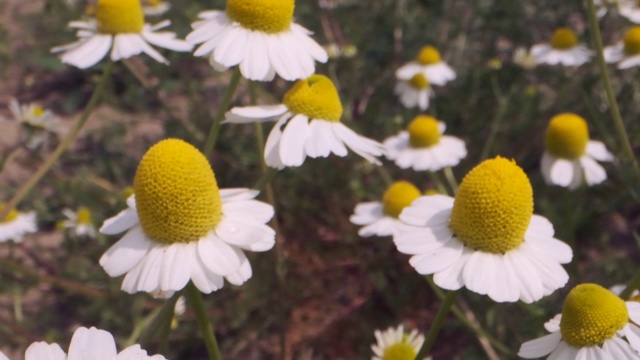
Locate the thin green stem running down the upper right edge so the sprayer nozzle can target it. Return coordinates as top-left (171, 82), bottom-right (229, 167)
top-left (587, 0), bottom-right (640, 190)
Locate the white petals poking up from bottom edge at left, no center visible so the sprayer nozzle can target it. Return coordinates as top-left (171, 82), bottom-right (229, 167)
top-left (19, 327), bottom-right (165, 360)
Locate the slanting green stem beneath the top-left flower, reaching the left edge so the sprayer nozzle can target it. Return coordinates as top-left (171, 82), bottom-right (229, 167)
top-left (0, 60), bottom-right (114, 219)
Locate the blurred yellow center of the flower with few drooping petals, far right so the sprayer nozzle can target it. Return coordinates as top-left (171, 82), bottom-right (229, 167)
top-left (544, 113), bottom-right (589, 159)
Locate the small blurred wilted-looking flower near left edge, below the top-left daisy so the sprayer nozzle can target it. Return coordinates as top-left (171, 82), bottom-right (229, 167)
top-left (0, 99), bottom-right (67, 150)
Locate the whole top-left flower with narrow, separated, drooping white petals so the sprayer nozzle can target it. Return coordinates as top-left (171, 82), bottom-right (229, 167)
top-left (51, 0), bottom-right (192, 69)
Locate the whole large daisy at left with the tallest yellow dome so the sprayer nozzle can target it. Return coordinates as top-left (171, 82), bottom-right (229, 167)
top-left (100, 139), bottom-right (275, 297)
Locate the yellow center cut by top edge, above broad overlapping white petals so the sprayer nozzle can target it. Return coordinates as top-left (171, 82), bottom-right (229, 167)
top-left (227, 0), bottom-right (295, 34)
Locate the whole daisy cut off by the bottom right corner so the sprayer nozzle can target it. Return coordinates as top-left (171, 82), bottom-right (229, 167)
top-left (518, 284), bottom-right (640, 360)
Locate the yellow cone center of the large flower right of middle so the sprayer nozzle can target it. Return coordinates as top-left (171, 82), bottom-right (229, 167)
top-left (449, 157), bottom-right (533, 254)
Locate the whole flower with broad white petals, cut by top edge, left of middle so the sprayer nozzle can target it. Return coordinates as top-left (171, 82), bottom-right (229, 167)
top-left (187, 0), bottom-right (328, 81)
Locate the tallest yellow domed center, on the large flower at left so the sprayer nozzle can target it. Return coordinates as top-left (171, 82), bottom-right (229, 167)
top-left (133, 139), bottom-right (222, 244)
